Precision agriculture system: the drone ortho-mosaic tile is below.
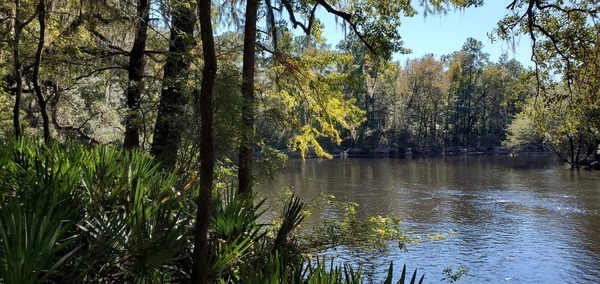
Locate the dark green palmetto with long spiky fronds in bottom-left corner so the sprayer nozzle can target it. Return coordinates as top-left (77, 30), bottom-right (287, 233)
top-left (0, 192), bottom-right (81, 283)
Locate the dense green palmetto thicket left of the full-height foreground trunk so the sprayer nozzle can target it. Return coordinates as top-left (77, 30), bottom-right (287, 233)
top-left (0, 140), bottom-right (190, 283)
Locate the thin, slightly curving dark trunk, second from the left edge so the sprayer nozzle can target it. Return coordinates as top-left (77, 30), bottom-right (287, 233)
top-left (32, 0), bottom-right (50, 143)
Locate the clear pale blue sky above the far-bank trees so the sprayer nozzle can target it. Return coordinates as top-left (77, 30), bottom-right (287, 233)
top-left (321, 0), bottom-right (532, 66)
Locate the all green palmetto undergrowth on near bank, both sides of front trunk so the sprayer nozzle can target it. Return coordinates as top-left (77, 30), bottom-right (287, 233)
top-left (0, 140), bottom-right (432, 284)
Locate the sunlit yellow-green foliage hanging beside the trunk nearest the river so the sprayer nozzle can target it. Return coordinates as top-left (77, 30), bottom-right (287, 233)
top-left (261, 42), bottom-right (365, 158)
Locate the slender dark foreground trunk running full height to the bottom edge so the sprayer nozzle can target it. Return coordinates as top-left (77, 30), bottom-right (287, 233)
top-left (192, 0), bottom-right (217, 284)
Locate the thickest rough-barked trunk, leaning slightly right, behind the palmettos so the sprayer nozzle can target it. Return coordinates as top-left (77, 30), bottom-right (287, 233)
top-left (150, 3), bottom-right (196, 170)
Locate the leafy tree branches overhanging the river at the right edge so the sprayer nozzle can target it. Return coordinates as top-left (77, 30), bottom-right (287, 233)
top-left (498, 0), bottom-right (600, 167)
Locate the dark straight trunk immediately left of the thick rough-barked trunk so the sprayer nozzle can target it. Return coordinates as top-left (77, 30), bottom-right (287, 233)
top-left (123, 0), bottom-right (150, 149)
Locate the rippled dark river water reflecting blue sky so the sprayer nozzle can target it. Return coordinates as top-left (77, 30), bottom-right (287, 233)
top-left (257, 155), bottom-right (600, 283)
